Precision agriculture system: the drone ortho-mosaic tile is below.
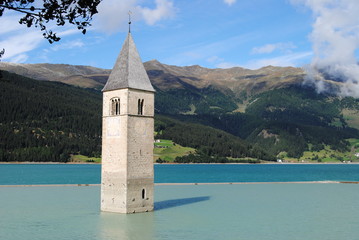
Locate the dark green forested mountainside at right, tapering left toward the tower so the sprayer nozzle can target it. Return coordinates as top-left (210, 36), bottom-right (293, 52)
top-left (169, 86), bottom-right (359, 158)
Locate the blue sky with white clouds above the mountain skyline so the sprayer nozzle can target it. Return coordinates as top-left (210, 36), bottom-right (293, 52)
top-left (0, 0), bottom-right (359, 69)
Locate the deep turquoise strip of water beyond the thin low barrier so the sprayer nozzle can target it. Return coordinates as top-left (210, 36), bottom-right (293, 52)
top-left (0, 164), bottom-right (359, 185)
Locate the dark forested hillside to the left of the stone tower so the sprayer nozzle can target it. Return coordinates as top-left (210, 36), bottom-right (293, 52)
top-left (0, 71), bottom-right (102, 162)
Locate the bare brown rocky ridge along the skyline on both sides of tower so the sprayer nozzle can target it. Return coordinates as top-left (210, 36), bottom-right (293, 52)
top-left (0, 60), bottom-right (304, 96)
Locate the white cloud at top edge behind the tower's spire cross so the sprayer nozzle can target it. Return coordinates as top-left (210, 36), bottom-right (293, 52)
top-left (93, 0), bottom-right (176, 33)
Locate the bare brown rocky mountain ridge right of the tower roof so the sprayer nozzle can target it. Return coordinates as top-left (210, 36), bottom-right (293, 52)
top-left (145, 60), bottom-right (304, 96)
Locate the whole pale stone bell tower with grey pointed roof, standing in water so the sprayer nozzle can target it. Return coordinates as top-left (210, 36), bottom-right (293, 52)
top-left (101, 33), bottom-right (155, 213)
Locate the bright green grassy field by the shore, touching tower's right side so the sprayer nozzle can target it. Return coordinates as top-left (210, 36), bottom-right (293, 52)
top-left (153, 139), bottom-right (195, 162)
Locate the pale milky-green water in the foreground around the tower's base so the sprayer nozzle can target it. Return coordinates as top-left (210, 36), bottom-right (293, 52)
top-left (0, 183), bottom-right (359, 240)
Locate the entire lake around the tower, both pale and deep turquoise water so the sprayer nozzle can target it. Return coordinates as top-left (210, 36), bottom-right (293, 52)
top-left (0, 164), bottom-right (359, 240)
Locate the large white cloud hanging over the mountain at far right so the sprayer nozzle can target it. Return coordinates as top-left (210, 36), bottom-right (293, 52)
top-left (291, 0), bottom-right (359, 97)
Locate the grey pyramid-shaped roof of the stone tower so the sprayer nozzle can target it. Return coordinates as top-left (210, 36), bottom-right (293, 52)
top-left (102, 33), bottom-right (155, 92)
